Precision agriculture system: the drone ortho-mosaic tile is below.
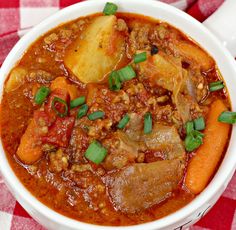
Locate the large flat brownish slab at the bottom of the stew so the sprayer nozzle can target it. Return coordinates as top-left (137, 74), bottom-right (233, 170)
top-left (106, 159), bottom-right (184, 213)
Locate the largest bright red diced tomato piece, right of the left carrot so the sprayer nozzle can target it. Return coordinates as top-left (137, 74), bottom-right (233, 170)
top-left (41, 117), bottom-right (75, 148)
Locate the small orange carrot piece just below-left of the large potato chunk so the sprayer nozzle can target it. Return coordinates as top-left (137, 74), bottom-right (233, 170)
top-left (50, 77), bottom-right (78, 100)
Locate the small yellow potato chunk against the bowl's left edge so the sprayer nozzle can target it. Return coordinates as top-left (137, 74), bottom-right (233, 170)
top-left (5, 67), bottom-right (28, 93)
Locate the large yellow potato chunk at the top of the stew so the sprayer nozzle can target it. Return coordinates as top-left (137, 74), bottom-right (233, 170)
top-left (64, 15), bottom-right (125, 83)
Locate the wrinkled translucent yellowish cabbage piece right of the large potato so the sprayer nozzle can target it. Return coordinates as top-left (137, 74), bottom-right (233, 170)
top-left (140, 52), bottom-right (197, 123)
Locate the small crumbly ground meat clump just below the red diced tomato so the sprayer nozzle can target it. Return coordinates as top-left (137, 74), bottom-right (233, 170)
top-left (49, 149), bottom-right (69, 173)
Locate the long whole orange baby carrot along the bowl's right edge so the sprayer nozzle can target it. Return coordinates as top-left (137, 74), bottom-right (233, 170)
top-left (185, 100), bottom-right (230, 194)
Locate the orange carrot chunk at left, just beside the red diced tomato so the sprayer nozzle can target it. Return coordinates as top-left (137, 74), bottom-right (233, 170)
top-left (16, 119), bottom-right (42, 164)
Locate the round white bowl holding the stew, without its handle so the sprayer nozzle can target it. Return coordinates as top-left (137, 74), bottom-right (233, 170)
top-left (0, 0), bottom-right (236, 230)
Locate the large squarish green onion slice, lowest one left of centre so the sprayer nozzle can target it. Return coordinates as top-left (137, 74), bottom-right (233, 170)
top-left (85, 141), bottom-right (107, 164)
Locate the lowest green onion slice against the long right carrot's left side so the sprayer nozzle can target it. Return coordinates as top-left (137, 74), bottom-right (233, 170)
top-left (184, 130), bottom-right (204, 152)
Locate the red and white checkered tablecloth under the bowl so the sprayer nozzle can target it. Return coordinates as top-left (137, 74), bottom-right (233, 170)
top-left (0, 0), bottom-right (236, 230)
